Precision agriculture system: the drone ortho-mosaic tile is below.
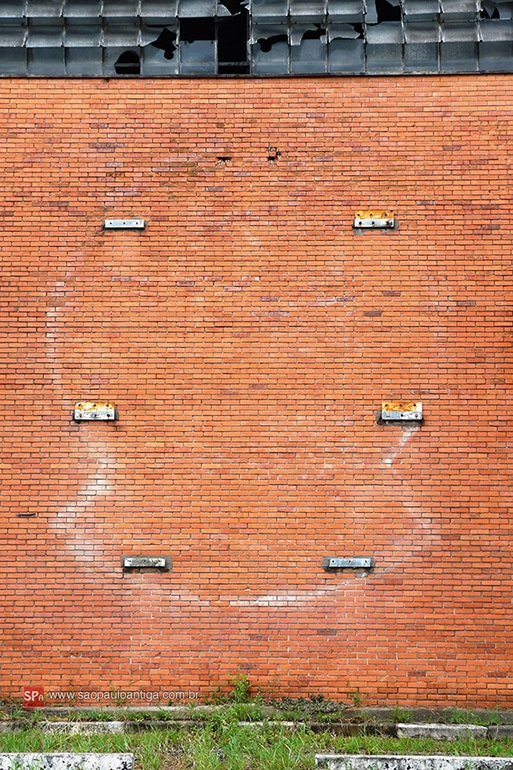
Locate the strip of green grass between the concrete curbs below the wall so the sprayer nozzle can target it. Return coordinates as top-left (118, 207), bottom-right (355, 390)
top-left (0, 713), bottom-right (513, 770)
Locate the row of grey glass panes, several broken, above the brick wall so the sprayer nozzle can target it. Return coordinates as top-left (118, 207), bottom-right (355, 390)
top-left (0, 0), bottom-right (513, 77)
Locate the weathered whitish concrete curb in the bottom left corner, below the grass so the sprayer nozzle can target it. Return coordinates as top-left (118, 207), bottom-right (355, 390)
top-left (0, 753), bottom-right (134, 770)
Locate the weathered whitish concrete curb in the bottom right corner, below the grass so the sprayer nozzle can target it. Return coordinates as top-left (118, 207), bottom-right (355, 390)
top-left (315, 754), bottom-right (513, 770)
